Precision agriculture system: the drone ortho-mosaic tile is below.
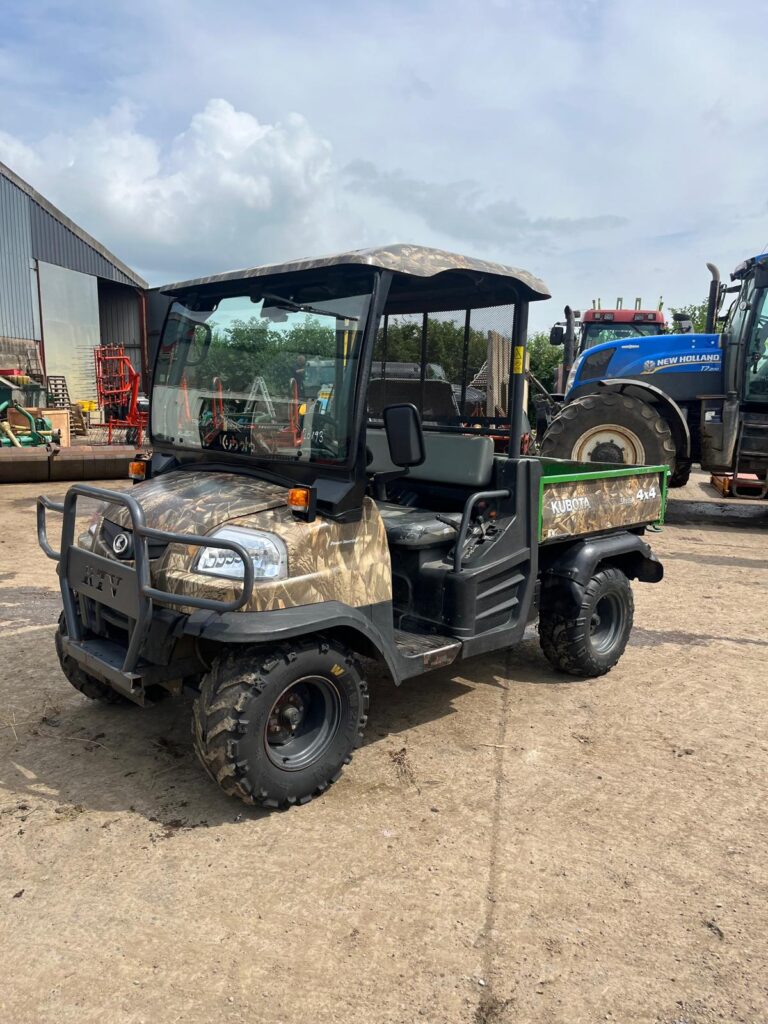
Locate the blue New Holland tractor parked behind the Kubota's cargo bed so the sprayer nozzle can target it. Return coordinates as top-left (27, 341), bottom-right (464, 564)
top-left (541, 254), bottom-right (768, 497)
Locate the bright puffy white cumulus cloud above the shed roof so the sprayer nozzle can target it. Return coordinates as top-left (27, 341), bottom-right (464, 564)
top-left (0, 99), bottom-right (342, 280)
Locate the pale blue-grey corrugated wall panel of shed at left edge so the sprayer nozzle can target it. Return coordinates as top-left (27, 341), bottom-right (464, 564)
top-left (0, 169), bottom-right (40, 341)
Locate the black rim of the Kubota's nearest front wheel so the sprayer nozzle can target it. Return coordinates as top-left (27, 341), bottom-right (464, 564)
top-left (264, 676), bottom-right (342, 771)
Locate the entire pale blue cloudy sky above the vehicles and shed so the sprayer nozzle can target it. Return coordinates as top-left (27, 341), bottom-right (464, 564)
top-left (0, 0), bottom-right (768, 329)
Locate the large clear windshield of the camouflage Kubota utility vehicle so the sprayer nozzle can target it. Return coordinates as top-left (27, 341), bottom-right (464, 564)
top-left (152, 271), bottom-right (374, 463)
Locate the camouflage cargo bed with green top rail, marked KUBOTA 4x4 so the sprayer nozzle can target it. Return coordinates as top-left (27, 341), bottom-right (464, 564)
top-left (539, 459), bottom-right (669, 544)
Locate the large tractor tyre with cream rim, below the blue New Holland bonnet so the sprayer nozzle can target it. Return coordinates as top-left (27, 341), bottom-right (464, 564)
top-left (542, 391), bottom-right (677, 469)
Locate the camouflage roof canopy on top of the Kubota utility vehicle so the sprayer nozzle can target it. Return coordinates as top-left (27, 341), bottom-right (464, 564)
top-left (160, 245), bottom-right (550, 312)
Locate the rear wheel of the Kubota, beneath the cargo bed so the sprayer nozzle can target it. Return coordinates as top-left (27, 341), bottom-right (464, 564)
top-left (539, 567), bottom-right (635, 678)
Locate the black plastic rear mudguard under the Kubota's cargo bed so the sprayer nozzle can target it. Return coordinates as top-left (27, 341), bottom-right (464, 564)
top-left (542, 532), bottom-right (664, 603)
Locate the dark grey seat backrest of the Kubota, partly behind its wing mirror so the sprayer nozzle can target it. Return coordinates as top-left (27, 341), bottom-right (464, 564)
top-left (366, 427), bottom-right (494, 488)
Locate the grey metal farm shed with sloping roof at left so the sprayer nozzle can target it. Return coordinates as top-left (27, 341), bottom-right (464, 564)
top-left (0, 163), bottom-right (147, 398)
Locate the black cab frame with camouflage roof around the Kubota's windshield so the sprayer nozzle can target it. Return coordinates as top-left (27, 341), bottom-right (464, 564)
top-left (150, 246), bottom-right (549, 519)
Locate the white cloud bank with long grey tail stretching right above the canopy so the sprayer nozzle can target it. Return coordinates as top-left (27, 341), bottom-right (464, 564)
top-left (0, 99), bottom-right (624, 296)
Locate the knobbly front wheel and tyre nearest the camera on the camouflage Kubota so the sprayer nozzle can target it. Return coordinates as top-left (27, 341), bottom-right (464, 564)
top-left (193, 637), bottom-right (369, 808)
